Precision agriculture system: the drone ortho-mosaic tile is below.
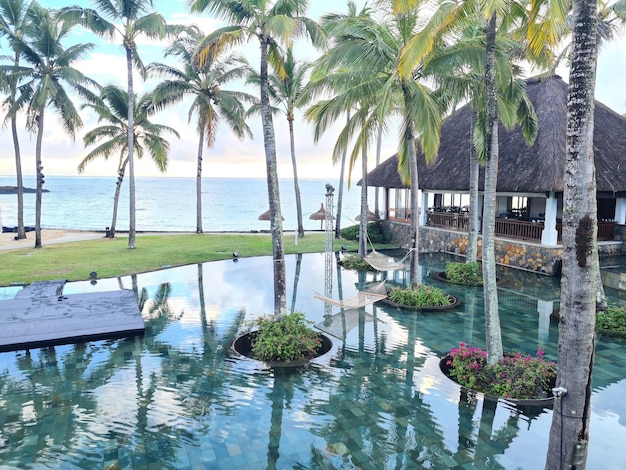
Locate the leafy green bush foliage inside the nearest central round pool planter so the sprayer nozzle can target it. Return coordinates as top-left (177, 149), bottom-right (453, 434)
top-left (250, 312), bottom-right (322, 362)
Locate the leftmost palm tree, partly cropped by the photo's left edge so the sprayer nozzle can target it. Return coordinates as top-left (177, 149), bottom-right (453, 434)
top-left (0, 0), bottom-right (31, 239)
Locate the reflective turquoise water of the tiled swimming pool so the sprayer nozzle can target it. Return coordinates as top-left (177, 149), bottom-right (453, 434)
top-left (0, 254), bottom-right (626, 470)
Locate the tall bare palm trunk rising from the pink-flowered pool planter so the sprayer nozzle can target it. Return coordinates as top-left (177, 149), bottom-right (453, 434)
top-left (483, 13), bottom-right (503, 364)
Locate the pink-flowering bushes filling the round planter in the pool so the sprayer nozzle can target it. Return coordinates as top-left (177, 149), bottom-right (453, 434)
top-left (446, 343), bottom-right (556, 399)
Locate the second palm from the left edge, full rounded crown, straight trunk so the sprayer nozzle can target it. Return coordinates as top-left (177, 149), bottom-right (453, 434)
top-left (2, 5), bottom-right (98, 248)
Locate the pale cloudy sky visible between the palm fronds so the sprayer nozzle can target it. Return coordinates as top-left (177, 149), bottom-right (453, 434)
top-left (0, 0), bottom-right (626, 180)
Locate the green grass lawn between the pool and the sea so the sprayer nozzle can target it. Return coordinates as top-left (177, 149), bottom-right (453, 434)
top-left (0, 233), bottom-right (370, 286)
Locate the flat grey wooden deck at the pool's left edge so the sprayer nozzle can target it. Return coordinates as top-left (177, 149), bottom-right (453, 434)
top-left (0, 281), bottom-right (145, 351)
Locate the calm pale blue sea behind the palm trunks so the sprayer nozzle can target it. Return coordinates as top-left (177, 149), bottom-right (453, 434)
top-left (0, 176), bottom-right (361, 232)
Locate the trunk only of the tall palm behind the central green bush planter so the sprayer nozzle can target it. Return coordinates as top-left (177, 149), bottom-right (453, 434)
top-left (259, 36), bottom-right (287, 316)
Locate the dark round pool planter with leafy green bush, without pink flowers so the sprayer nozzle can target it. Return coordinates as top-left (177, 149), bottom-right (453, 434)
top-left (232, 312), bottom-right (332, 366)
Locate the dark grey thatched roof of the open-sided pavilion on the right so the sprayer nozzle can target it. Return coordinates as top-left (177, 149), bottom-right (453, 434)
top-left (367, 77), bottom-right (626, 193)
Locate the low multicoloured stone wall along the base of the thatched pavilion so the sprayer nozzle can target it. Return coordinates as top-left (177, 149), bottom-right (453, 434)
top-left (383, 220), bottom-right (624, 275)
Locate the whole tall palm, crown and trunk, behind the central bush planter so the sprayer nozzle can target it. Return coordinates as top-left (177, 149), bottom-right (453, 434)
top-left (191, 0), bottom-right (325, 315)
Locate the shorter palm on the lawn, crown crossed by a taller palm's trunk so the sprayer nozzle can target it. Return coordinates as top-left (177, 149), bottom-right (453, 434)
top-left (78, 85), bottom-right (178, 238)
